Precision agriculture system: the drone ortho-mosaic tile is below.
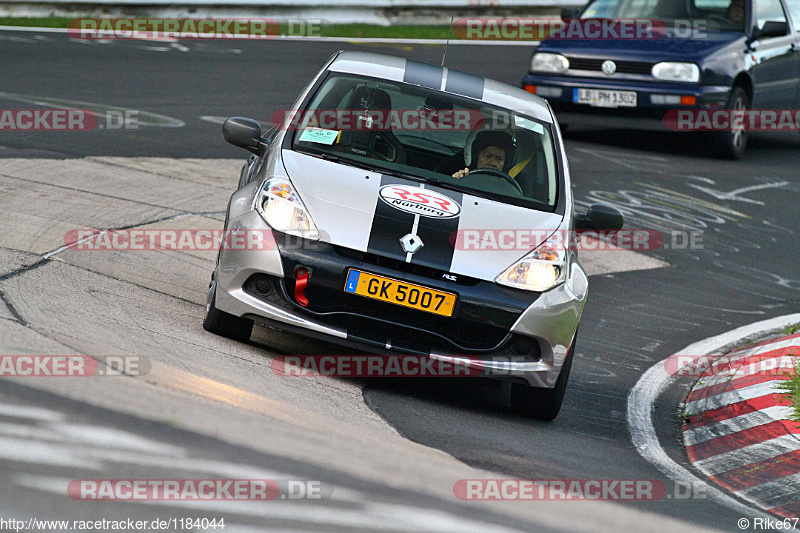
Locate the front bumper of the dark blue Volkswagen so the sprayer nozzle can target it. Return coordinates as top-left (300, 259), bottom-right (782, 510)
top-left (522, 74), bottom-right (731, 131)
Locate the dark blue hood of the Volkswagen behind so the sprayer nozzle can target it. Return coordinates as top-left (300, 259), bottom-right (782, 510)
top-left (537, 31), bottom-right (745, 62)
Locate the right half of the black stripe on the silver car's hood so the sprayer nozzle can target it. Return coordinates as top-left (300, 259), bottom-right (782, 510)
top-left (411, 183), bottom-right (463, 272)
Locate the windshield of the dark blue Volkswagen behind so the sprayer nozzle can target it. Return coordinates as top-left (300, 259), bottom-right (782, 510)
top-left (580, 0), bottom-right (746, 32)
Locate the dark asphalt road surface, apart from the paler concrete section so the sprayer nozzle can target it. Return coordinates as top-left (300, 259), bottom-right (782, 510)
top-left (0, 32), bottom-right (800, 531)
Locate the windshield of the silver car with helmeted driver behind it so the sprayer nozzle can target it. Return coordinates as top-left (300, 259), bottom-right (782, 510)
top-left (291, 74), bottom-right (558, 211)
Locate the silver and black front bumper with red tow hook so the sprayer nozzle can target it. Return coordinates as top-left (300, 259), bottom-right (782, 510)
top-left (215, 211), bottom-right (587, 387)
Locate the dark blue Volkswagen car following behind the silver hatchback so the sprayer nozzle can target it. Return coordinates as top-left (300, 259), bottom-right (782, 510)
top-left (522, 0), bottom-right (800, 159)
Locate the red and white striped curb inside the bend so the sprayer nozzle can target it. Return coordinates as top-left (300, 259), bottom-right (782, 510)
top-left (683, 334), bottom-right (800, 518)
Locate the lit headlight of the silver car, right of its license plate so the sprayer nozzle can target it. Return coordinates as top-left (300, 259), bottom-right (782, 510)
top-left (495, 233), bottom-right (567, 292)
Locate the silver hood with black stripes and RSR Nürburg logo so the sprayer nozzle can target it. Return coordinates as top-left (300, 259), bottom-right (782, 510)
top-left (282, 150), bottom-right (563, 281)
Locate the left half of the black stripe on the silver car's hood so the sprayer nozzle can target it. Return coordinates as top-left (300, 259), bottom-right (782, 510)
top-left (367, 175), bottom-right (419, 261)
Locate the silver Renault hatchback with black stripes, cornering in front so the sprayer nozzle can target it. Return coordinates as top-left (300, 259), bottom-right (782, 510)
top-left (203, 52), bottom-right (622, 420)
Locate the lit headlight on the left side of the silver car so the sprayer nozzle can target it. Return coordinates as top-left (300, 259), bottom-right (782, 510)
top-left (256, 178), bottom-right (319, 241)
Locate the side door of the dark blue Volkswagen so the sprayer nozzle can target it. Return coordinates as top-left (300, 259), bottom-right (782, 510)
top-left (750, 0), bottom-right (800, 109)
